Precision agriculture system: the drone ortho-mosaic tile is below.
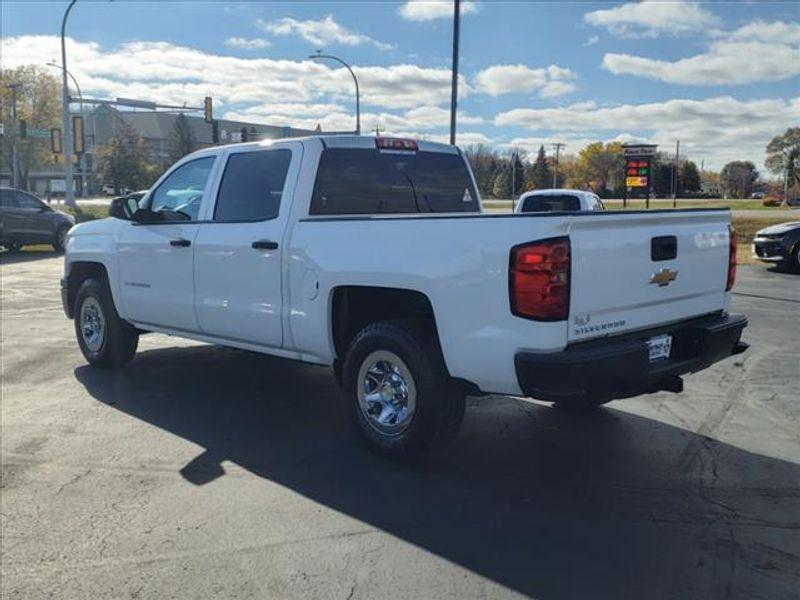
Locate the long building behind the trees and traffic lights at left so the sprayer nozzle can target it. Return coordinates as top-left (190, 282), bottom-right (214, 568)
top-left (0, 104), bottom-right (316, 196)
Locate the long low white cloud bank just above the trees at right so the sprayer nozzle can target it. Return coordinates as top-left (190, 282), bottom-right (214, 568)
top-left (495, 96), bottom-right (800, 167)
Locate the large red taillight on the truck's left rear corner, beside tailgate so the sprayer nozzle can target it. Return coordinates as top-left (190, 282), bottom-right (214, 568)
top-left (509, 237), bottom-right (570, 321)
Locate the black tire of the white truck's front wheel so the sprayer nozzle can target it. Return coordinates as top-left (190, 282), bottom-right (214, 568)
top-left (74, 278), bottom-right (139, 369)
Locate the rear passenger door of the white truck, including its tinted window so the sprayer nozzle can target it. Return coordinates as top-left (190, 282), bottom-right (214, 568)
top-left (194, 143), bottom-right (302, 348)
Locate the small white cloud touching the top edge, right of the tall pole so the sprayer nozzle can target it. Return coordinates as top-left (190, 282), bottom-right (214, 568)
top-left (583, 0), bottom-right (720, 37)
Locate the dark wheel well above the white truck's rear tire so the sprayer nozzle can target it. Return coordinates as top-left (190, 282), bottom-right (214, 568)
top-left (331, 286), bottom-right (436, 357)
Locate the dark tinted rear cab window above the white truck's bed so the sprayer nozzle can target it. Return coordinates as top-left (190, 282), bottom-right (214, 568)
top-left (309, 148), bottom-right (480, 215)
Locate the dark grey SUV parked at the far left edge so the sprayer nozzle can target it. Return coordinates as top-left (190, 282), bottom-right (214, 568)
top-left (0, 187), bottom-right (75, 251)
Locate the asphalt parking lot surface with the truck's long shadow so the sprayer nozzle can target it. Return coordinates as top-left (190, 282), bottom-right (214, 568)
top-left (0, 252), bottom-right (800, 599)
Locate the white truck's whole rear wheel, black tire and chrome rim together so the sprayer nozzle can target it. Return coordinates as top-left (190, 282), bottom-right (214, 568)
top-left (342, 320), bottom-right (465, 458)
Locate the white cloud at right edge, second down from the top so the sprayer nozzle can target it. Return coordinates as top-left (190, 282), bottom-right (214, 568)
top-left (603, 21), bottom-right (800, 85)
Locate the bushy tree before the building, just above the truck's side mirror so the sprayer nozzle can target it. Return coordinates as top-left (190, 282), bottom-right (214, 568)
top-left (97, 123), bottom-right (160, 193)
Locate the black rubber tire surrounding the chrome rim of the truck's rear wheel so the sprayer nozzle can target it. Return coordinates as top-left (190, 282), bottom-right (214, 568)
top-left (342, 320), bottom-right (465, 459)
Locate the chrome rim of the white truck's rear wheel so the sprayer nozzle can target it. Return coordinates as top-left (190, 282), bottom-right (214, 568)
top-left (358, 350), bottom-right (417, 435)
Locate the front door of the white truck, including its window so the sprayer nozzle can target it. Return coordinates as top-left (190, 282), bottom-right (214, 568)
top-left (117, 156), bottom-right (216, 332)
